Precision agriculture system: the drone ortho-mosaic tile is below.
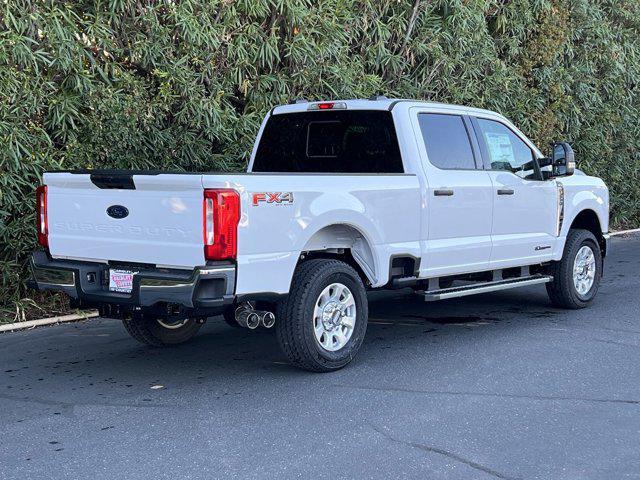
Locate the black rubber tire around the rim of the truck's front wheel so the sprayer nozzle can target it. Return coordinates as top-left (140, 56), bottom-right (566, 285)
top-left (547, 229), bottom-right (603, 310)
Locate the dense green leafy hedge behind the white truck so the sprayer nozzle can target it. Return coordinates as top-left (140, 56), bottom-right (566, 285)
top-left (0, 0), bottom-right (640, 318)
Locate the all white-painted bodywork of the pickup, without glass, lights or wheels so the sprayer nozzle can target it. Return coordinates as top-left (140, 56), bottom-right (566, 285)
top-left (44, 100), bottom-right (609, 295)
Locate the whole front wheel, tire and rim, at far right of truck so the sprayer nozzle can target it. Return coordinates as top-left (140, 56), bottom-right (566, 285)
top-left (547, 229), bottom-right (603, 309)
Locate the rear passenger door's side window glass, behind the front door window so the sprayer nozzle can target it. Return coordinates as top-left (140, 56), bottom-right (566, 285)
top-left (418, 113), bottom-right (476, 169)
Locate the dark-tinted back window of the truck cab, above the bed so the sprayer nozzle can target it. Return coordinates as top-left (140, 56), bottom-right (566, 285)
top-left (252, 110), bottom-right (404, 173)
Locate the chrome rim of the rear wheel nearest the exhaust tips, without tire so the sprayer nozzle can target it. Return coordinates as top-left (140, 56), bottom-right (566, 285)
top-left (313, 283), bottom-right (356, 352)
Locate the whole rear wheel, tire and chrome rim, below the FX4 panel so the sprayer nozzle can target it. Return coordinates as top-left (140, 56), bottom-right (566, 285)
top-left (276, 259), bottom-right (369, 372)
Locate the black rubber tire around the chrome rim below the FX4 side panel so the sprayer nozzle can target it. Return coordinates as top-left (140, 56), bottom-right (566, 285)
top-left (276, 259), bottom-right (369, 372)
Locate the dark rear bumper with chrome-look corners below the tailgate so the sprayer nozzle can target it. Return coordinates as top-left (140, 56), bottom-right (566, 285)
top-left (31, 250), bottom-right (236, 312)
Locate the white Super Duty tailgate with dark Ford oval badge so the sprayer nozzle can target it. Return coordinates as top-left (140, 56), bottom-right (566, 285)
top-left (44, 172), bottom-right (205, 268)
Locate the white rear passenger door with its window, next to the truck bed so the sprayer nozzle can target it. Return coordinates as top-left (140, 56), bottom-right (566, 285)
top-left (412, 108), bottom-right (493, 277)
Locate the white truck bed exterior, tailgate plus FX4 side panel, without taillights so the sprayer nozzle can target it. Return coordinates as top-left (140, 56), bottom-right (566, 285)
top-left (44, 171), bottom-right (420, 294)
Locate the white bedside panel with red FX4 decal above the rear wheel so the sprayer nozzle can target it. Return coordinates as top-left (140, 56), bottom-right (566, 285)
top-left (203, 173), bottom-right (420, 295)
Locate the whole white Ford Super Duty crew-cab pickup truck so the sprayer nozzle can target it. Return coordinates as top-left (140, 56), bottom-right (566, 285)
top-left (32, 97), bottom-right (609, 371)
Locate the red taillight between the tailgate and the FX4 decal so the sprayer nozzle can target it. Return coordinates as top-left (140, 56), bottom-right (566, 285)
top-left (202, 189), bottom-right (240, 260)
